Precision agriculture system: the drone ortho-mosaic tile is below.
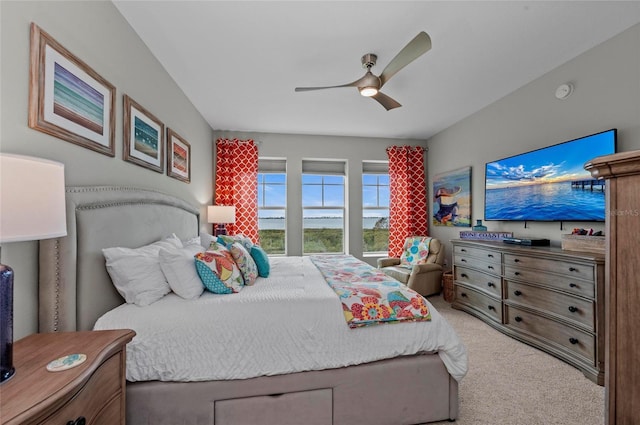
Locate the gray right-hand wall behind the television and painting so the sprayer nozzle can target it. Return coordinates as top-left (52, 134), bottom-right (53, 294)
top-left (427, 24), bottom-right (640, 264)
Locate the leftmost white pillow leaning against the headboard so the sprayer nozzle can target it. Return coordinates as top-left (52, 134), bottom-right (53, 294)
top-left (102, 236), bottom-right (182, 306)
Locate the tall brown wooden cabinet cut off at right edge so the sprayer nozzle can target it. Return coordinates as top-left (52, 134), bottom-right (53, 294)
top-left (585, 151), bottom-right (640, 425)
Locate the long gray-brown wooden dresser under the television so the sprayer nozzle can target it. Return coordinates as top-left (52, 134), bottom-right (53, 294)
top-left (452, 240), bottom-right (605, 385)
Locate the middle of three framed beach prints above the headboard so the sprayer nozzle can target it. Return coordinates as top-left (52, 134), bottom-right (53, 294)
top-left (122, 94), bottom-right (164, 173)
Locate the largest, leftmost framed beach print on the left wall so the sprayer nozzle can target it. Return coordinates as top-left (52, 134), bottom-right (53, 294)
top-left (29, 23), bottom-right (116, 156)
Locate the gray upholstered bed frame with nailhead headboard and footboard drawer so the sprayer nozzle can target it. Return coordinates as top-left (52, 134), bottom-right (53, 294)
top-left (39, 186), bottom-right (466, 425)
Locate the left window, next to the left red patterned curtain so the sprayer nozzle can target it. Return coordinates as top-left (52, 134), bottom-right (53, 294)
top-left (258, 159), bottom-right (287, 255)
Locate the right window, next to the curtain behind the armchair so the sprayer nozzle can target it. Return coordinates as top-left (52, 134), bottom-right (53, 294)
top-left (362, 162), bottom-right (389, 255)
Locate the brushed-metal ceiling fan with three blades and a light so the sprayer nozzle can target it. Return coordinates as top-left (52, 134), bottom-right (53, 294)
top-left (295, 31), bottom-right (431, 111)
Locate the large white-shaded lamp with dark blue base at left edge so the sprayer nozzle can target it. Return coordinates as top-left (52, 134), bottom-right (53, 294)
top-left (0, 153), bottom-right (67, 383)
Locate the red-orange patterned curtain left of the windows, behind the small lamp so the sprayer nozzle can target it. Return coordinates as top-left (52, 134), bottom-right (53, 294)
top-left (214, 139), bottom-right (260, 244)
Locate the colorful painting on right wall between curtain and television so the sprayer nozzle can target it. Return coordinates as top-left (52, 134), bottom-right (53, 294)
top-left (433, 167), bottom-right (471, 227)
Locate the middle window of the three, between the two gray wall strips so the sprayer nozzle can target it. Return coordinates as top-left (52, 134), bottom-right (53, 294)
top-left (302, 161), bottom-right (345, 254)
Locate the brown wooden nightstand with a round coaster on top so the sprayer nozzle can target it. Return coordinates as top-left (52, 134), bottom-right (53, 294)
top-left (0, 329), bottom-right (135, 425)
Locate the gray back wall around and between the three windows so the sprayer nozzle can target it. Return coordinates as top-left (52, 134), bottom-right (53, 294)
top-left (215, 131), bottom-right (426, 265)
